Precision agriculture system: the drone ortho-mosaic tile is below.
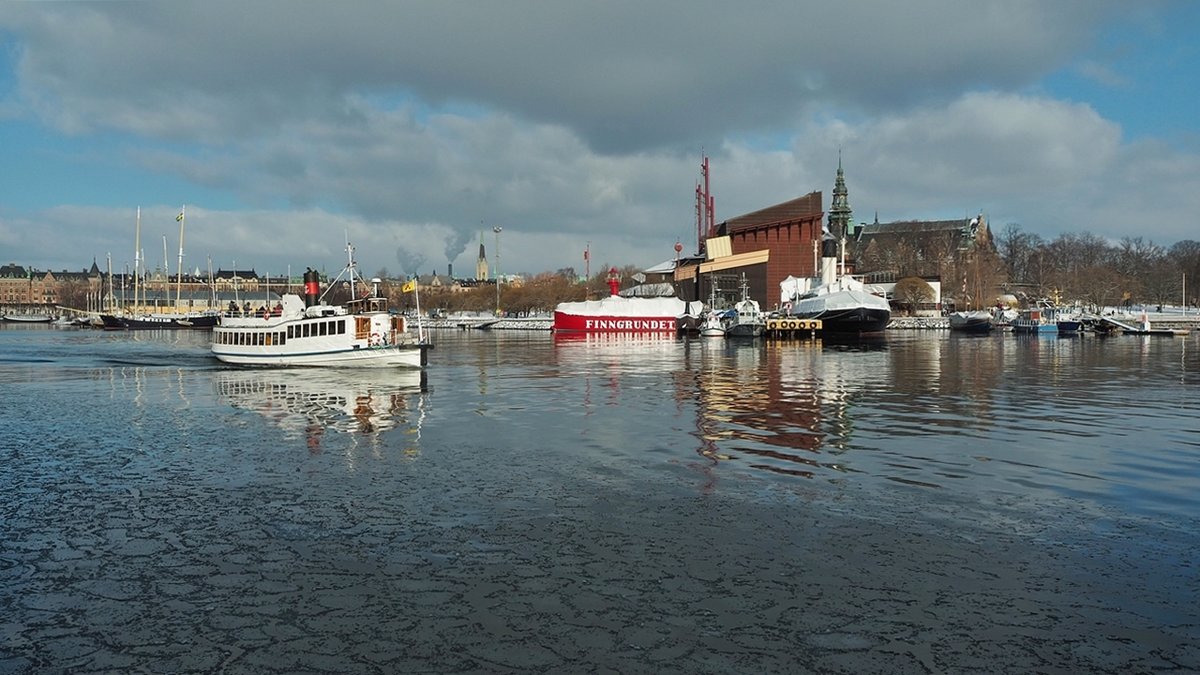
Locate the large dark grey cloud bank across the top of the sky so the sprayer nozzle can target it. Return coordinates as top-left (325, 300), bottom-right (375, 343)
top-left (0, 0), bottom-right (1120, 147)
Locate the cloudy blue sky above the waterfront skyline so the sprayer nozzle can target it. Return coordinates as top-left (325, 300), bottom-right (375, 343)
top-left (0, 0), bottom-right (1200, 276)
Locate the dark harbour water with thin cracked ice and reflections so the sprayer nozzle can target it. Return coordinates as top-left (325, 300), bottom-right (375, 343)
top-left (0, 327), bottom-right (1200, 674)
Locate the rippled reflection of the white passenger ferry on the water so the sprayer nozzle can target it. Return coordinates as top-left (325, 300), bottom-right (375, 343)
top-left (215, 369), bottom-right (427, 453)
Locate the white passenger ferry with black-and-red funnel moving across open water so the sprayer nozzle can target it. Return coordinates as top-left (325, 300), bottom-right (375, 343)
top-left (212, 244), bottom-right (432, 368)
